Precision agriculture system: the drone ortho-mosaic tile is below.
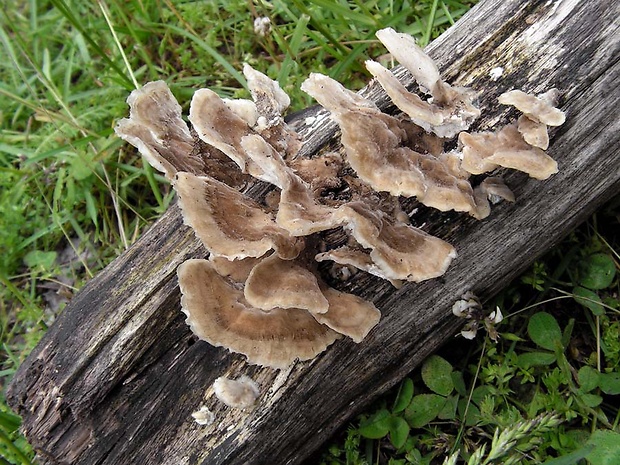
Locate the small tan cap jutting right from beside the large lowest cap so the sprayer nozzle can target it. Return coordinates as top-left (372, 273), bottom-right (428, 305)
top-left (313, 288), bottom-right (381, 343)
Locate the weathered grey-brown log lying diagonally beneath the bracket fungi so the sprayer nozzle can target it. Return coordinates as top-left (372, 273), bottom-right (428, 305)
top-left (7, 0), bottom-right (620, 464)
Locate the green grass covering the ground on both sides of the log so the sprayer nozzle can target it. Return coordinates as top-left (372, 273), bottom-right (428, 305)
top-left (0, 0), bottom-right (620, 464)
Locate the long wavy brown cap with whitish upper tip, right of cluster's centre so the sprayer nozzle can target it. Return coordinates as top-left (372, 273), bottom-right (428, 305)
top-left (302, 73), bottom-right (474, 211)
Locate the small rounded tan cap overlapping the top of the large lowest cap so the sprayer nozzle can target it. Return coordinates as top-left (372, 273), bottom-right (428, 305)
top-left (244, 255), bottom-right (329, 314)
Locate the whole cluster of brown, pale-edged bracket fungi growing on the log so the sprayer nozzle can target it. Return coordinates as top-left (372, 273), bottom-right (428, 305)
top-left (116, 28), bottom-right (564, 368)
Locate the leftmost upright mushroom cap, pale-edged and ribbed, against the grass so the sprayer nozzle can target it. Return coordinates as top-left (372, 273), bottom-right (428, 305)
top-left (114, 81), bottom-right (204, 180)
